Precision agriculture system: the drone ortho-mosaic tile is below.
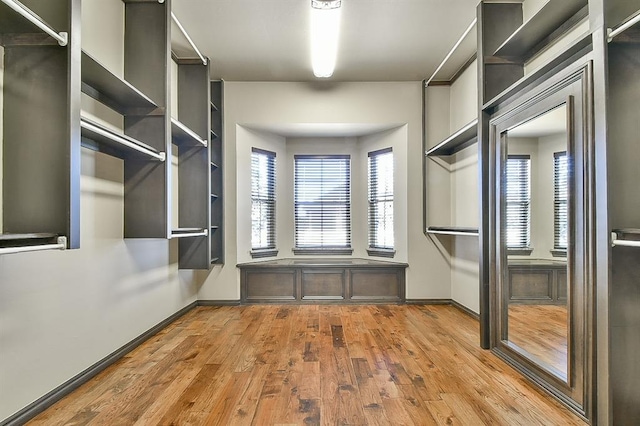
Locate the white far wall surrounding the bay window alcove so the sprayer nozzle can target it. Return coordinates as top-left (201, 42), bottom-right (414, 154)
top-left (199, 82), bottom-right (450, 300)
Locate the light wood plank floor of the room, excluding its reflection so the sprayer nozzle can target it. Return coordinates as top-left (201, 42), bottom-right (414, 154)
top-left (30, 305), bottom-right (584, 426)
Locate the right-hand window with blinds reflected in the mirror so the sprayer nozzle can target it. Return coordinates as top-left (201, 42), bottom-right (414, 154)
top-left (553, 151), bottom-right (569, 250)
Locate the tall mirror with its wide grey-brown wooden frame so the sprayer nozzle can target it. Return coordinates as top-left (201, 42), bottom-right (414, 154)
top-left (490, 65), bottom-right (597, 418)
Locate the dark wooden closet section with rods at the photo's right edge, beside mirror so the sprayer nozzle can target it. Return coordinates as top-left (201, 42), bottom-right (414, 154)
top-left (599, 0), bottom-right (640, 424)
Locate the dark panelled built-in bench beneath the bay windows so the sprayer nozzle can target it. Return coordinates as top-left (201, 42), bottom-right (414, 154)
top-left (237, 258), bottom-right (409, 303)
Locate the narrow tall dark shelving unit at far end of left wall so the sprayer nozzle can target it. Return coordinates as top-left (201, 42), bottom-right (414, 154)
top-left (209, 81), bottom-right (224, 265)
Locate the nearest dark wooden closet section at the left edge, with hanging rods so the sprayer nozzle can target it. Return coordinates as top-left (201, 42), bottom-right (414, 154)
top-left (0, 0), bottom-right (80, 248)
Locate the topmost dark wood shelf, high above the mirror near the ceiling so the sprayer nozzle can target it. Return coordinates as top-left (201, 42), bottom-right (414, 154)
top-left (494, 0), bottom-right (588, 57)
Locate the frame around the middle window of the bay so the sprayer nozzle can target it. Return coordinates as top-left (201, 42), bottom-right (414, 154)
top-left (292, 154), bottom-right (353, 255)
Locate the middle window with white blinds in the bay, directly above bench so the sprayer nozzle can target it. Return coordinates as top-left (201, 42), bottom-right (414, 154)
top-left (294, 155), bottom-right (351, 250)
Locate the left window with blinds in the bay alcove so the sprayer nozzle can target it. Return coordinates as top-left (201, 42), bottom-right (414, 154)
top-left (251, 148), bottom-right (276, 250)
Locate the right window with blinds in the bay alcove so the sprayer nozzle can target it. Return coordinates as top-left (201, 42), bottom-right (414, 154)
top-left (369, 148), bottom-right (393, 250)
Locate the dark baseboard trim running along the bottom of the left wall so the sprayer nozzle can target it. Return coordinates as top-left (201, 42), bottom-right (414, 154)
top-left (0, 301), bottom-right (200, 426)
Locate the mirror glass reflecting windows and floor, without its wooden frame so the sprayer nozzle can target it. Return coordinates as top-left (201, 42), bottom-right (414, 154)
top-left (501, 105), bottom-right (570, 381)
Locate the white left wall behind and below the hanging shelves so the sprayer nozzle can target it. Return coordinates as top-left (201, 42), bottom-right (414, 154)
top-left (0, 0), bottom-right (200, 422)
